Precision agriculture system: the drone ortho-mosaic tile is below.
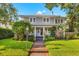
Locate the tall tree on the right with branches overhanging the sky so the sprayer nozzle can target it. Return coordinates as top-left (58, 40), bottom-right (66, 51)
top-left (45, 3), bottom-right (79, 32)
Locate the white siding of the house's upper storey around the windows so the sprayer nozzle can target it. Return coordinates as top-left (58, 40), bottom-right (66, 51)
top-left (29, 17), bottom-right (64, 25)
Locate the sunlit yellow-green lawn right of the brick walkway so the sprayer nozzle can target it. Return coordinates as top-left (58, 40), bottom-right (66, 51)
top-left (45, 40), bottom-right (79, 56)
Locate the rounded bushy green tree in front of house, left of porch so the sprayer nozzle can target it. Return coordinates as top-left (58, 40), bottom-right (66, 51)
top-left (12, 21), bottom-right (32, 40)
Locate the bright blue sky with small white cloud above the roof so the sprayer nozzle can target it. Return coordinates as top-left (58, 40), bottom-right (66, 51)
top-left (13, 3), bottom-right (66, 16)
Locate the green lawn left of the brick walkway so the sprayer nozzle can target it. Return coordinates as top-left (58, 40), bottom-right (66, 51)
top-left (0, 39), bottom-right (32, 56)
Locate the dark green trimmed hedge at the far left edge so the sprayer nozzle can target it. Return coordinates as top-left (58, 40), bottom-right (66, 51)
top-left (0, 28), bottom-right (14, 39)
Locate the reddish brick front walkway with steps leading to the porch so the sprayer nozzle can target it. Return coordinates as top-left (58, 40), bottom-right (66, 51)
top-left (30, 39), bottom-right (48, 56)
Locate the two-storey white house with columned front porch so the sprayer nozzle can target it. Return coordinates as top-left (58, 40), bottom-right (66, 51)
top-left (19, 15), bottom-right (66, 37)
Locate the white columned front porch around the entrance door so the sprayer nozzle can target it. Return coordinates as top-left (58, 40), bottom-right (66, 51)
top-left (33, 26), bottom-right (50, 40)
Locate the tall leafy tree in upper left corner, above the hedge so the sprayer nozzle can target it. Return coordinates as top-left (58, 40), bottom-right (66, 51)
top-left (0, 3), bottom-right (17, 26)
